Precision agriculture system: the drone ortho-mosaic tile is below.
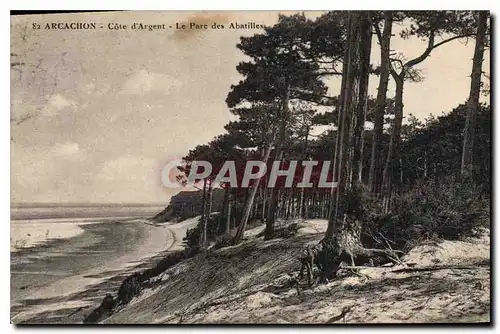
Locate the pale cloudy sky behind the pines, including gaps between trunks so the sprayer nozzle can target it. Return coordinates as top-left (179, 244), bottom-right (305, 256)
top-left (11, 11), bottom-right (489, 203)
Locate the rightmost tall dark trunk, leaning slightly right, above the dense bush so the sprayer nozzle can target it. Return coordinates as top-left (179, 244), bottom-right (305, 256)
top-left (460, 11), bottom-right (489, 176)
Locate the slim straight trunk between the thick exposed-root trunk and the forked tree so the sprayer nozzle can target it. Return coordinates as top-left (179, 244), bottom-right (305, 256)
top-left (368, 11), bottom-right (392, 194)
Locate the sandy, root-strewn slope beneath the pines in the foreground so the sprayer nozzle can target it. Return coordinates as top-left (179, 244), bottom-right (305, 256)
top-left (103, 220), bottom-right (491, 324)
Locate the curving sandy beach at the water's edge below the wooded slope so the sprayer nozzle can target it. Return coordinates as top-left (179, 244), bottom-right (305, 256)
top-left (11, 218), bottom-right (196, 323)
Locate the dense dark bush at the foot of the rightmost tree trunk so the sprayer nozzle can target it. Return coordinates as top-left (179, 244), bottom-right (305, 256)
top-left (374, 180), bottom-right (490, 249)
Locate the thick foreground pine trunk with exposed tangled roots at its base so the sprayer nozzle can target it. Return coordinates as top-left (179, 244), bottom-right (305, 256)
top-left (319, 11), bottom-right (406, 278)
